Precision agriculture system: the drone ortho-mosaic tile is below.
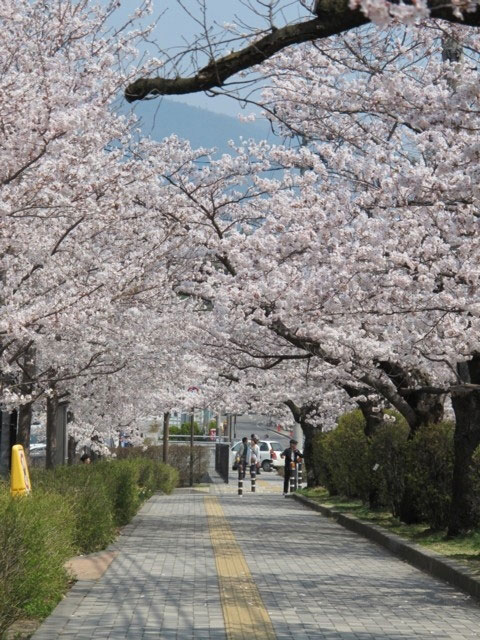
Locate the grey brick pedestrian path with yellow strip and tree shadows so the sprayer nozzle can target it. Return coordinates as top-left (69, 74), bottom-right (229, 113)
top-left (33, 477), bottom-right (480, 640)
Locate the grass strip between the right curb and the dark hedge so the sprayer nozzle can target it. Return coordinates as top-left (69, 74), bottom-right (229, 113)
top-left (298, 487), bottom-right (480, 577)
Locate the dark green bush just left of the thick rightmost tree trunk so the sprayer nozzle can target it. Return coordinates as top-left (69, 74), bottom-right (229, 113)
top-left (407, 422), bottom-right (455, 529)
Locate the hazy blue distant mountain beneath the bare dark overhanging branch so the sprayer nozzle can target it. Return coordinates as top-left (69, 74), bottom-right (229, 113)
top-left (128, 99), bottom-right (280, 154)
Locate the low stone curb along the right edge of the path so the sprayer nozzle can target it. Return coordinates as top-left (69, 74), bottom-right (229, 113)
top-left (292, 493), bottom-right (480, 600)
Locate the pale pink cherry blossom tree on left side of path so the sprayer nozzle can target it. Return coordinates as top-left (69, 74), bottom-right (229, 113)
top-left (0, 0), bottom-right (209, 457)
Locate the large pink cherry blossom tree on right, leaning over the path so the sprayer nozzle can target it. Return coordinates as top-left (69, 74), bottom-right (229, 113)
top-left (152, 18), bottom-right (478, 530)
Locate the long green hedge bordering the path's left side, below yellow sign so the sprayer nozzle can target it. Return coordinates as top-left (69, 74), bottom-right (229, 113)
top-left (0, 458), bottom-right (178, 637)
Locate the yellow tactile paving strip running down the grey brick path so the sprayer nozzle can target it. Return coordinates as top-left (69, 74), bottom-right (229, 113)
top-left (204, 496), bottom-right (276, 640)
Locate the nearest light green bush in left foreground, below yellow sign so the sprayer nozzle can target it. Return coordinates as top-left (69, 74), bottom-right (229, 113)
top-left (0, 489), bottom-right (75, 632)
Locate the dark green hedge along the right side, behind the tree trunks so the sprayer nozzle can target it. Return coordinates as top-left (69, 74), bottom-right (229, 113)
top-left (313, 410), bottom-right (464, 530)
